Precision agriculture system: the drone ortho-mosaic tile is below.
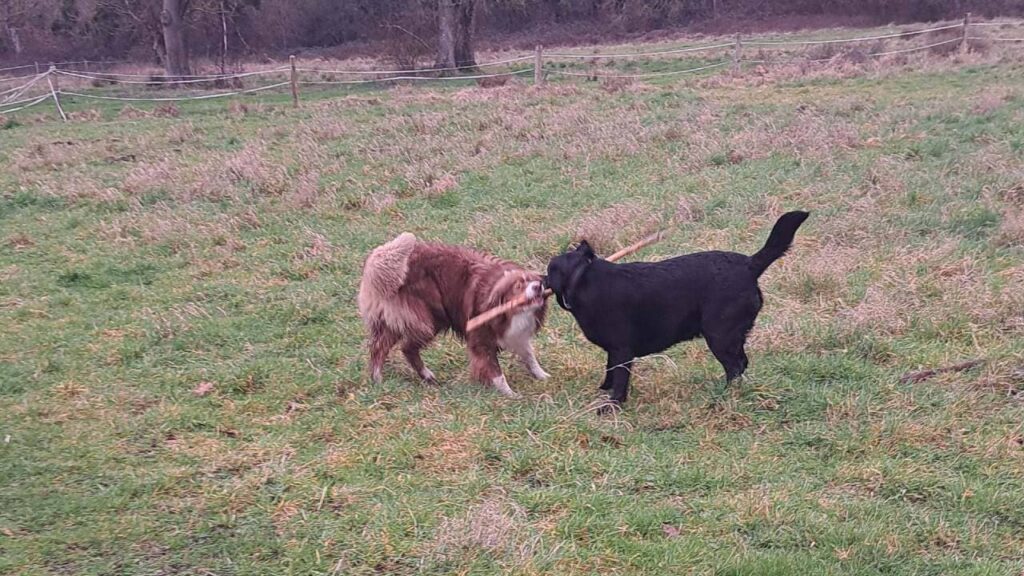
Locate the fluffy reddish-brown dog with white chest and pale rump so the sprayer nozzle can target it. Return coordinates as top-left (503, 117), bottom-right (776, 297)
top-left (358, 233), bottom-right (548, 398)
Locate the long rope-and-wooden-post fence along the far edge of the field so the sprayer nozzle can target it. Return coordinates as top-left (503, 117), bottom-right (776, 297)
top-left (0, 14), bottom-right (1024, 119)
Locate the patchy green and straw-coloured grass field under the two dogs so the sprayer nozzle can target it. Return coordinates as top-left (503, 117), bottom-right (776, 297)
top-left (0, 45), bottom-right (1024, 576)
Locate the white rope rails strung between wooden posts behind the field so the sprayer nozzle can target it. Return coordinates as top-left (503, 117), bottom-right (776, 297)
top-left (0, 14), bottom-right (1024, 119)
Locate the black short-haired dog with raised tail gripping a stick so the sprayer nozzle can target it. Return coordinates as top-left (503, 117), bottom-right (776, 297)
top-left (547, 212), bottom-right (809, 410)
